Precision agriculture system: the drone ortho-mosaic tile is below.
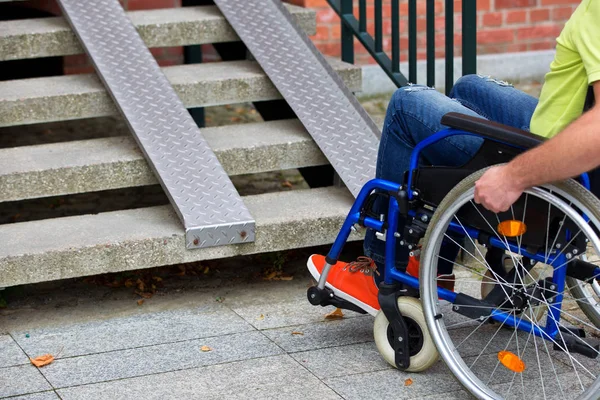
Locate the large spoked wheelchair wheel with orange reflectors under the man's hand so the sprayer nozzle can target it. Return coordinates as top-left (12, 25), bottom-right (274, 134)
top-left (420, 171), bottom-right (600, 399)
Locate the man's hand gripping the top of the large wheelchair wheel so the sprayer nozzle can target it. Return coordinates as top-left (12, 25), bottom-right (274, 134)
top-left (475, 165), bottom-right (523, 213)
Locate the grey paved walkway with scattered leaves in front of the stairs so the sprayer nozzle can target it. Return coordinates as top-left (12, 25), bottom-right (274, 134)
top-left (0, 255), bottom-right (470, 400)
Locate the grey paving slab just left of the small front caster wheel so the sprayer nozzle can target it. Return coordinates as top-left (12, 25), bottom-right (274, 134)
top-left (262, 316), bottom-right (373, 353)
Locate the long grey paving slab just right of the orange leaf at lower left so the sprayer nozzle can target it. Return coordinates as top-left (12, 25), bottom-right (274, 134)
top-left (41, 332), bottom-right (281, 388)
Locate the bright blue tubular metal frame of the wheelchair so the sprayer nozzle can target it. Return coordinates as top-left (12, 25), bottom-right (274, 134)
top-left (319, 128), bottom-right (600, 340)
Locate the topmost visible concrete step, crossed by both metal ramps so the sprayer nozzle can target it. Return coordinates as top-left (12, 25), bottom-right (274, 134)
top-left (0, 5), bottom-right (316, 61)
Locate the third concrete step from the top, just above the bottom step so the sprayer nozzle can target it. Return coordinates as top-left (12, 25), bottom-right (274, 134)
top-left (0, 120), bottom-right (327, 202)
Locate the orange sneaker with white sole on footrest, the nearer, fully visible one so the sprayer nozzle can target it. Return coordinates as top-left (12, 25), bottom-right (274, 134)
top-left (306, 254), bottom-right (380, 315)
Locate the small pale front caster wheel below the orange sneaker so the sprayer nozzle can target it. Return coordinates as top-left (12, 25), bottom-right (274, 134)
top-left (373, 297), bottom-right (439, 372)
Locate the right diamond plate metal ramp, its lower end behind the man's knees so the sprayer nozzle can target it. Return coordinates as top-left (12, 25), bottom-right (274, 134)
top-left (215, 0), bottom-right (380, 196)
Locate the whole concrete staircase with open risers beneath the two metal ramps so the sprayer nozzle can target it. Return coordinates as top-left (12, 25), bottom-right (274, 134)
top-left (0, 1), bottom-right (361, 287)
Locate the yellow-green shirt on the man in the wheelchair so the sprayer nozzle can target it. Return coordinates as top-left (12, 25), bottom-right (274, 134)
top-left (530, 0), bottom-right (600, 137)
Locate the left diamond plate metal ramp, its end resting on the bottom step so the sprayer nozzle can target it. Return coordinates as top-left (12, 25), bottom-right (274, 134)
top-left (59, 0), bottom-right (254, 248)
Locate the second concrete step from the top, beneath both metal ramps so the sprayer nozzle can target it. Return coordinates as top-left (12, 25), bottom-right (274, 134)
top-left (0, 58), bottom-right (362, 126)
